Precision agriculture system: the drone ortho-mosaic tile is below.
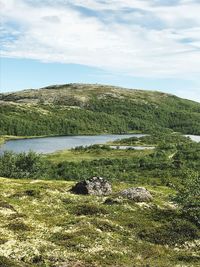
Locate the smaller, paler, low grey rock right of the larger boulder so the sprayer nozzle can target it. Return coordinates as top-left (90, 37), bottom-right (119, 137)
top-left (120, 187), bottom-right (153, 202)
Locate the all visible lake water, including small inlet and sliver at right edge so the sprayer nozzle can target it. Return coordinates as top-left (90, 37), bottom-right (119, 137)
top-left (0, 133), bottom-right (200, 154)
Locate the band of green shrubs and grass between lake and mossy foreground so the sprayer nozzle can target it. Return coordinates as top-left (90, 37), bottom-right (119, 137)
top-left (0, 133), bottom-right (200, 186)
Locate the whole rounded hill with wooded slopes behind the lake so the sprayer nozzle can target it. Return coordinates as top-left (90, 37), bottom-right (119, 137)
top-left (0, 84), bottom-right (200, 136)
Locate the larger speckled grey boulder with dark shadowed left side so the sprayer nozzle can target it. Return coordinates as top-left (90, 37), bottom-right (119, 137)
top-left (71, 177), bottom-right (112, 196)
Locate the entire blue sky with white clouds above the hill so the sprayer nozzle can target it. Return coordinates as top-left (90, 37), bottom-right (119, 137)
top-left (0, 0), bottom-right (200, 102)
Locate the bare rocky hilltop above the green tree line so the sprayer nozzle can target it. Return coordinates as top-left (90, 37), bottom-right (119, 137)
top-left (0, 83), bottom-right (175, 105)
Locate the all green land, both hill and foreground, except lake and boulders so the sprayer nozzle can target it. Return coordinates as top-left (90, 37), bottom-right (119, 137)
top-left (0, 84), bottom-right (200, 267)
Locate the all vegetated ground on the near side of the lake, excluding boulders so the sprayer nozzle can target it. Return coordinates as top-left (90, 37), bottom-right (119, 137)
top-left (0, 131), bottom-right (200, 267)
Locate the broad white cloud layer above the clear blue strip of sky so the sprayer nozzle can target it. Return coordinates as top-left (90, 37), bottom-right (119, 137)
top-left (0, 0), bottom-right (200, 85)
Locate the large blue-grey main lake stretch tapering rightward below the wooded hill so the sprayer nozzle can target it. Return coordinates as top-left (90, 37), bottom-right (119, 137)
top-left (0, 134), bottom-right (144, 154)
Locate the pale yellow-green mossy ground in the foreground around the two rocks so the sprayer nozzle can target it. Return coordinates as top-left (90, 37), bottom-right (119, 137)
top-left (0, 178), bottom-right (200, 267)
